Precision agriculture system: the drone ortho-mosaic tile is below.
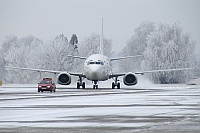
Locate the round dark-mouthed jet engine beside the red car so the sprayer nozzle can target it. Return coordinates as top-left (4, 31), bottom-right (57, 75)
top-left (57, 72), bottom-right (71, 85)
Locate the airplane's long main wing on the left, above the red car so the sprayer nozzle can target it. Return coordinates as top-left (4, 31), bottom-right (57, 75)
top-left (5, 66), bottom-right (85, 77)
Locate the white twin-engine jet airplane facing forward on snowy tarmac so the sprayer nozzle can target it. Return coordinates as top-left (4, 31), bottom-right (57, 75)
top-left (5, 19), bottom-right (194, 89)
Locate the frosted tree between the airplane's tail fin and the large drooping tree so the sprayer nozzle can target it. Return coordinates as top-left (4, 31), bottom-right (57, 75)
top-left (119, 21), bottom-right (155, 72)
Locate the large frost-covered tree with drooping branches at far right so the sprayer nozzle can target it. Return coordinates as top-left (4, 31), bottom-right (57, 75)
top-left (144, 24), bottom-right (195, 83)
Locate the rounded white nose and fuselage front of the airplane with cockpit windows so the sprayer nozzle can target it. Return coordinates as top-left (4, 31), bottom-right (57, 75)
top-left (84, 54), bottom-right (111, 81)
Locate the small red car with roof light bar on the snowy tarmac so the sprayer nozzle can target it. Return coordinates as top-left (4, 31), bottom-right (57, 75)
top-left (38, 78), bottom-right (56, 92)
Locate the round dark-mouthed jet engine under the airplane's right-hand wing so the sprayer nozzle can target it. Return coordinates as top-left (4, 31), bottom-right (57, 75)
top-left (123, 72), bottom-right (137, 86)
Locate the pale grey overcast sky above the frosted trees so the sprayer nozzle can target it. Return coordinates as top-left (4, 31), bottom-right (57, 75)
top-left (0, 0), bottom-right (200, 51)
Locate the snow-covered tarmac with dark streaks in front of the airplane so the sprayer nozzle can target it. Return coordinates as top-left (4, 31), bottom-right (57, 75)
top-left (0, 82), bottom-right (200, 132)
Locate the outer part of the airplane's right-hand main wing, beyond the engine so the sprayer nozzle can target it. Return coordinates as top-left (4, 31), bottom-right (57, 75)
top-left (135, 68), bottom-right (195, 75)
